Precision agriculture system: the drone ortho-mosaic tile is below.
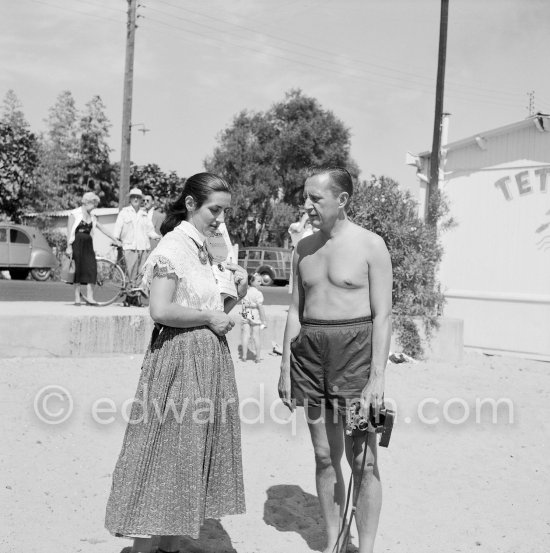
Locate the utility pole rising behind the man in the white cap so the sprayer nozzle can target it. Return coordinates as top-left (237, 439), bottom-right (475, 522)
top-left (118, 0), bottom-right (137, 209)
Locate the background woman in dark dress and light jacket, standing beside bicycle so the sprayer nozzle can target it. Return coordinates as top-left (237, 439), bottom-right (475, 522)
top-left (67, 192), bottom-right (122, 305)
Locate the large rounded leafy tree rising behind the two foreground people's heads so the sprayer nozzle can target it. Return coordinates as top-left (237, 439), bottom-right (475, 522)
top-left (205, 90), bottom-right (359, 245)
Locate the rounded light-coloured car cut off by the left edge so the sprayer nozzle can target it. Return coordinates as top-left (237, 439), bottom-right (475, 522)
top-left (0, 223), bottom-right (57, 280)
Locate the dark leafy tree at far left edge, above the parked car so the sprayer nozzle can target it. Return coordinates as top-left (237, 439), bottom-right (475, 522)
top-left (0, 90), bottom-right (38, 222)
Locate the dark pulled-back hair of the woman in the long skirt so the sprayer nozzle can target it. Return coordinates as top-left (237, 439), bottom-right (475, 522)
top-left (160, 173), bottom-right (231, 236)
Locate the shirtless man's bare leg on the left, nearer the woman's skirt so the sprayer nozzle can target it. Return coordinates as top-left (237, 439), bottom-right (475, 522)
top-left (306, 406), bottom-right (346, 553)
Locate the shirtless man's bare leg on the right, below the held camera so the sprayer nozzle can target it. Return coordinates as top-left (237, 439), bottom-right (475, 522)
top-left (346, 432), bottom-right (382, 553)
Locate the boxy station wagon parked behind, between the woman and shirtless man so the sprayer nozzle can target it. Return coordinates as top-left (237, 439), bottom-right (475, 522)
top-left (239, 246), bottom-right (292, 286)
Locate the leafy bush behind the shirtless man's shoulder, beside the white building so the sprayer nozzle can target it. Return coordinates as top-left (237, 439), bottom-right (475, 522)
top-left (350, 176), bottom-right (444, 357)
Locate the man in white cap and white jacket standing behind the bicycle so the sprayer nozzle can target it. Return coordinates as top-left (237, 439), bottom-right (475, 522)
top-left (114, 188), bottom-right (161, 285)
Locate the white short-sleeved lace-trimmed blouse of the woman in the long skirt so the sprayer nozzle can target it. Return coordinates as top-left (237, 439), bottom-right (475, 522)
top-left (142, 221), bottom-right (223, 311)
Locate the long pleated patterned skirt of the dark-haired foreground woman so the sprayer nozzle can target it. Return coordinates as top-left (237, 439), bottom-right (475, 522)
top-left (105, 327), bottom-right (245, 539)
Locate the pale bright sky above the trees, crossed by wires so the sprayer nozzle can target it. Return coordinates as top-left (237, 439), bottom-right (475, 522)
top-left (0, 0), bottom-right (550, 196)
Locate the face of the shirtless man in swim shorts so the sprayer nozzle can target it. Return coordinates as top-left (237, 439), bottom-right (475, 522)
top-left (304, 174), bottom-right (340, 229)
